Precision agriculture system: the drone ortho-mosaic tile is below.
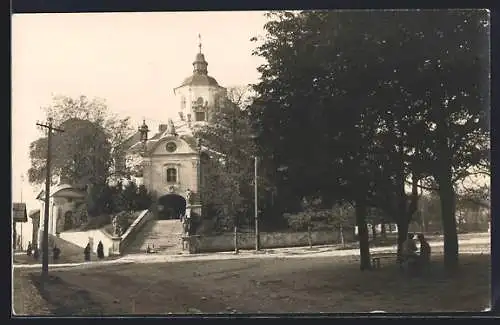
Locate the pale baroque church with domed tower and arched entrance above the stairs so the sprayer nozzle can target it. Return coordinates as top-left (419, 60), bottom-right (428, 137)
top-left (120, 37), bottom-right (231, 219)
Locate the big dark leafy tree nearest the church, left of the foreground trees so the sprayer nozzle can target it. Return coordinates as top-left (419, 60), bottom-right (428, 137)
top-left (252, 12), bottom-right (390, 269)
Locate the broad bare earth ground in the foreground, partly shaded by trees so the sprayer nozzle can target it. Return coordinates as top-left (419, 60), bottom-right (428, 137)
top-left (12, 255), bottom-right (490, 315)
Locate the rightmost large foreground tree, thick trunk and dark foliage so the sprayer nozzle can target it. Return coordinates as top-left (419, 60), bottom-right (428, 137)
top-left (390, 10), bottom-right (489, 270)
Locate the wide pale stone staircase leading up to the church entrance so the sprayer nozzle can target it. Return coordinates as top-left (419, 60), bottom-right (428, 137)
top-left (126, 220), bottom-right (182, 254)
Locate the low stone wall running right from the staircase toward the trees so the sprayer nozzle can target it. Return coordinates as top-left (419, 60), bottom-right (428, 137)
top-left (190, 230), bottom-right (354, 253)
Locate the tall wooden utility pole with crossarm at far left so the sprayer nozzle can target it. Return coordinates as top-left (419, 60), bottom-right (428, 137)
top-left (36, 118), bottom-right (64, 282)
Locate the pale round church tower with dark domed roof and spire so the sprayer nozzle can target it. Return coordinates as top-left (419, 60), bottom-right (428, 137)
top-left (174, 35), bottom-right (226, 127)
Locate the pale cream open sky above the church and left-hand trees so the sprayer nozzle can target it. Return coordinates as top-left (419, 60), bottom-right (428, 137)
top-left (11, 11), bottom-right (266, 210)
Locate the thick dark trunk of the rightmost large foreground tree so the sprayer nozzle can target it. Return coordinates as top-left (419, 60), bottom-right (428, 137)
top-left (439, 173), bottom-right (458, 271)
